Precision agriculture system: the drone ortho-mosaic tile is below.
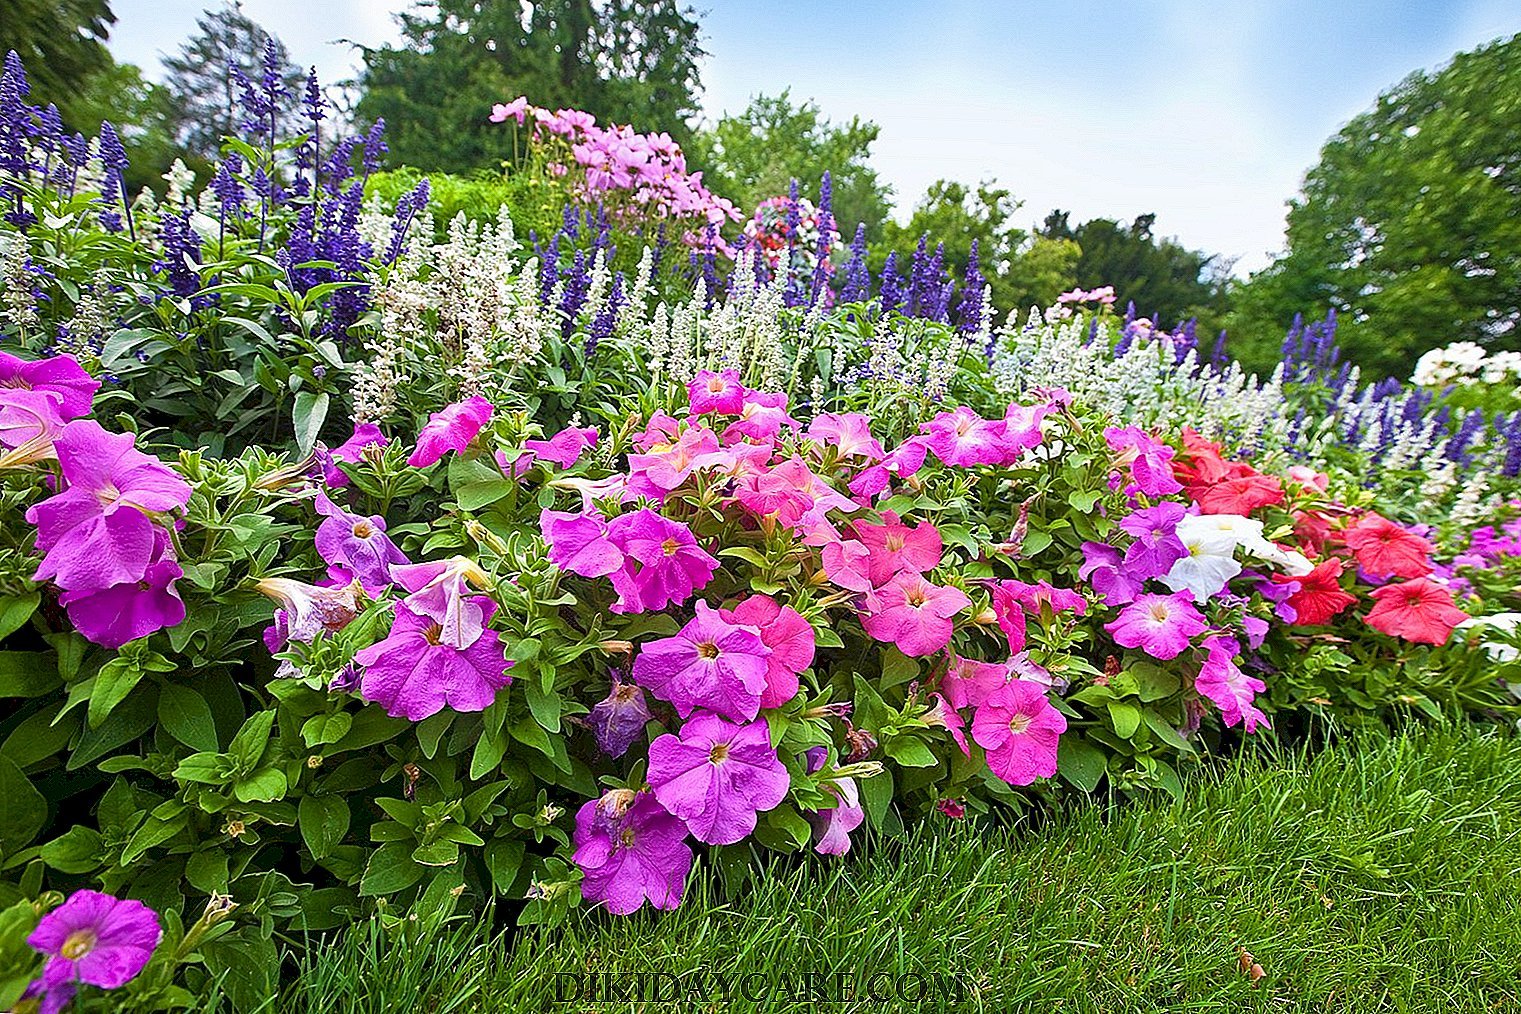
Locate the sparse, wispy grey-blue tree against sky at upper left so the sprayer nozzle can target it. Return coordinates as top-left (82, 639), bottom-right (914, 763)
top-left (164, 0), bottom-right (306, 158)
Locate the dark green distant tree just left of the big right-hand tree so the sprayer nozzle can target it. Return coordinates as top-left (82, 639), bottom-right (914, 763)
top-left (1040, 211), bottom-right (1230, 330)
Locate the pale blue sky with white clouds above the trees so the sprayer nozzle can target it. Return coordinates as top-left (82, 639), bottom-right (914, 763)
top-left (111, 0), bottom-right (1521, 275)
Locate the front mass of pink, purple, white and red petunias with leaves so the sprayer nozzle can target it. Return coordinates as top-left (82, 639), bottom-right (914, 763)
top-left (0, 329), bottom-right (1510, 1009)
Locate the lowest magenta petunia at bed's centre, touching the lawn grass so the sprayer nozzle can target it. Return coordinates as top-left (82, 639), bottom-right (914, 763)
top-left (572, 789), bottom-right (692, 915)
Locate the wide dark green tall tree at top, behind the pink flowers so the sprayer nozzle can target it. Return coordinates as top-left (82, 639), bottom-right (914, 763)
top-left (356, 0), bottom-right (704, 172)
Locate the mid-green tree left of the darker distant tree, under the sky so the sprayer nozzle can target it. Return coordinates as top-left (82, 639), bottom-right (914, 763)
top-left (870, 179), bottom-right (1080, 315)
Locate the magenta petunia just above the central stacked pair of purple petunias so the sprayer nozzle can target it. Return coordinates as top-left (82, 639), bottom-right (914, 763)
top-left (607, 508), bottom-right (718, 613)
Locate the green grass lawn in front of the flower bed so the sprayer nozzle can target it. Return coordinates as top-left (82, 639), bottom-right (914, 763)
top-left (275, 728), bottom-right (1521, 1014)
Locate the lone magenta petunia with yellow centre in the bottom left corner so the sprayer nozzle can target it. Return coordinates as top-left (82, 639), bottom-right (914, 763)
top-left (26, 889), bottom-right (164, 990)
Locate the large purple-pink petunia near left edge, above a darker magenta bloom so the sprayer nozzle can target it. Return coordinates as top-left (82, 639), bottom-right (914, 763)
top-left (26, 420), bottom-right (190, 591)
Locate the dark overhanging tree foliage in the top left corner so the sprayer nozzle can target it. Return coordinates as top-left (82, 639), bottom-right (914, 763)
top-left (0, 0), bottom-right (116, 122)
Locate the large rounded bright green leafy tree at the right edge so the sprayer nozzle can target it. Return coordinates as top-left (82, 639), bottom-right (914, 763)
top-left (1232, 35), bottom-right (1521, 375)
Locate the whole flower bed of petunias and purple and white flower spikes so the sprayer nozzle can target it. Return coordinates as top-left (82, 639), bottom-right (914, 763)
top-left (0, 53), bottom-right (1516, 1009)
